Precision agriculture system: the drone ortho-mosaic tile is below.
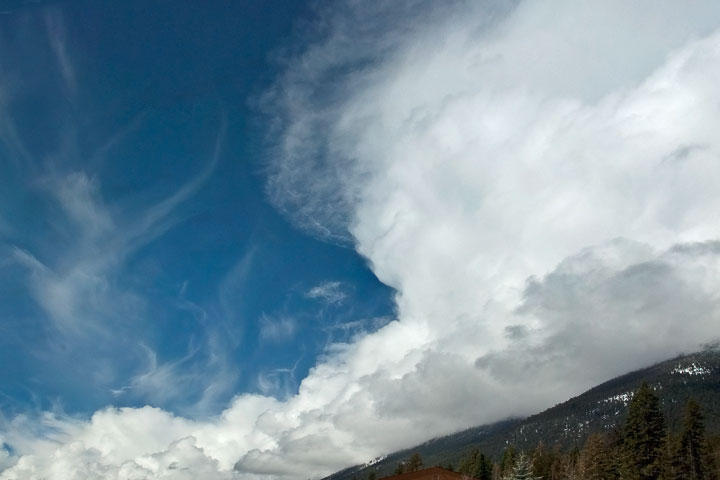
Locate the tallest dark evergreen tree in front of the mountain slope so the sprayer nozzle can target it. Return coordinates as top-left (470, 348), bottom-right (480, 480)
top-left (622, 382), bottom-right (665, 480)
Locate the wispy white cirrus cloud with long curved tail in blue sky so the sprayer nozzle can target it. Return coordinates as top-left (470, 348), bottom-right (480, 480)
top-left (3, 133), bottom-right (229, 414)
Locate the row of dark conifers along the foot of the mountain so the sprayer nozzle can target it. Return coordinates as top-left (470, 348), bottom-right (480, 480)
top-left (457, 383), bottom-right (720, 480)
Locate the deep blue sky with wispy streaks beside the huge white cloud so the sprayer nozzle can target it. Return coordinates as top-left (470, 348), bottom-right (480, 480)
top-left (0, 1), bottom-right (392, 415)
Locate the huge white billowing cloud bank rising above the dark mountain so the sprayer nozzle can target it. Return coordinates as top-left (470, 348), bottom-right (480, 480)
top-left (7, 0), bottom-right (720, 479)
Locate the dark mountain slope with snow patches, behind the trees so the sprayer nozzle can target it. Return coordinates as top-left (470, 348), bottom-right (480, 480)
top-left (324, 348), bottom-right (720, 480)
